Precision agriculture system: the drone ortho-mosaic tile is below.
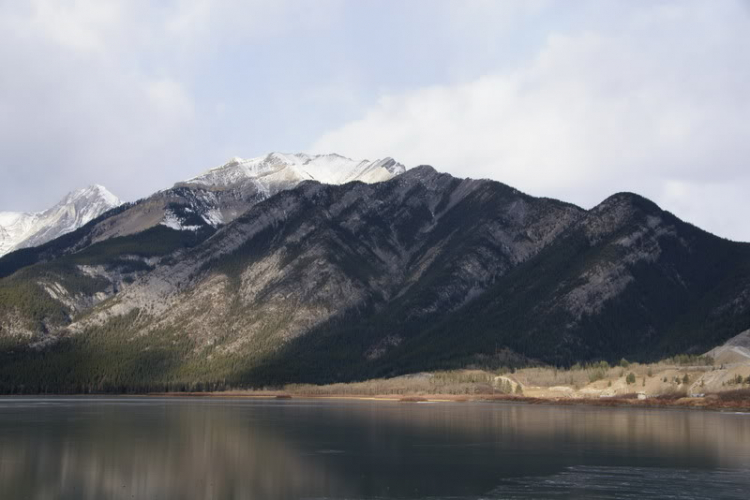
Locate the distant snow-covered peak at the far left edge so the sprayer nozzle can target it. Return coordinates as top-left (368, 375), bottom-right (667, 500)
top-left (0, 184), bottom-right (122, 256)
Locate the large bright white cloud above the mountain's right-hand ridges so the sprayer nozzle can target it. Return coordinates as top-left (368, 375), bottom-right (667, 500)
top-left (312, 2), bottom-right (750, 240)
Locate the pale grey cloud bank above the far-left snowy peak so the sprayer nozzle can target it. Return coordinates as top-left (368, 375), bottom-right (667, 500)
top-left (0, 1), bottom-right (195, 209)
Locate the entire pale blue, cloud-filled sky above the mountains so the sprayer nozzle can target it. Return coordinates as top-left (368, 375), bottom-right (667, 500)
top-left (0, 0), bottom-right (750, 241)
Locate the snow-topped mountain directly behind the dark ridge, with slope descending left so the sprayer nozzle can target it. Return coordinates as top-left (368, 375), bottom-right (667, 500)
top-left (0, 153), bottom-right (406, 278)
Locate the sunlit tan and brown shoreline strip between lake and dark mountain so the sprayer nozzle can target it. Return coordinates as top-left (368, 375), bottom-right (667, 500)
top-left (145, 357), bottom-right (750, 411)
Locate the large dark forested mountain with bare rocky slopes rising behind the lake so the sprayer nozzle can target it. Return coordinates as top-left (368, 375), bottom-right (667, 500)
top-left (0, 161), bottom-right (750, 392)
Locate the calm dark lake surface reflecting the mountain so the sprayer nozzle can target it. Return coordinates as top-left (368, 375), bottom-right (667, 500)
top-left (0, 398), bottom-right (750, 500)
